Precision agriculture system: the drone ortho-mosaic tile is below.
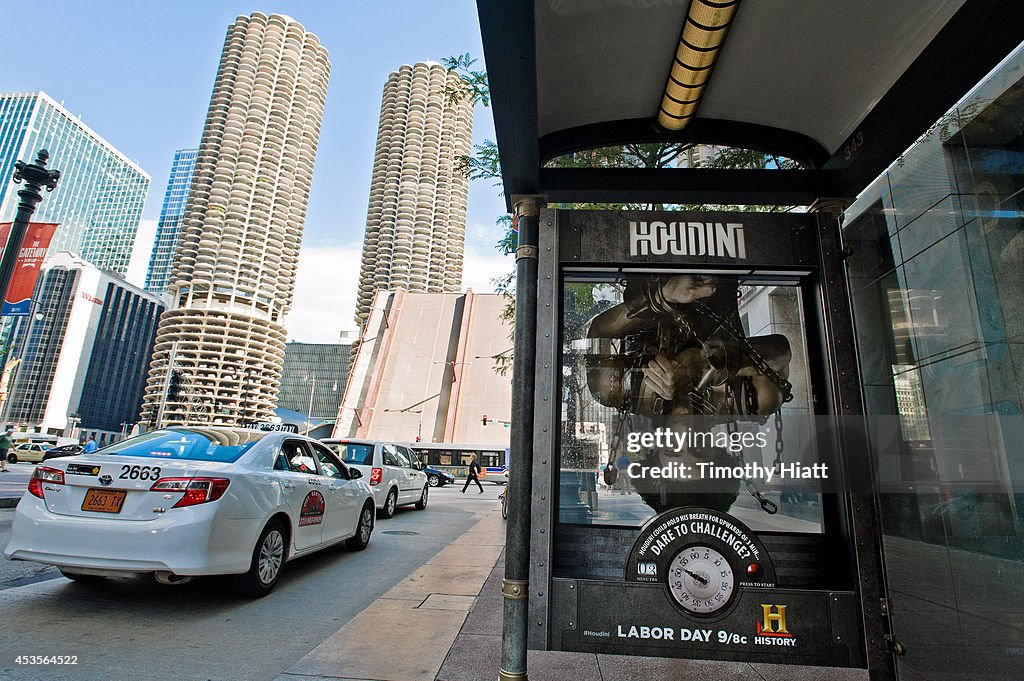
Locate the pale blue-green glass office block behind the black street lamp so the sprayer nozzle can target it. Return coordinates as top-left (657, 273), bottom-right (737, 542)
top-left (0, 92), bottom-right (150, 276)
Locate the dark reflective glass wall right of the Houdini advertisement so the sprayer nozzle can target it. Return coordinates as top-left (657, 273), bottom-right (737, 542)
top-left (844, 43), bottom-right (1024, 679)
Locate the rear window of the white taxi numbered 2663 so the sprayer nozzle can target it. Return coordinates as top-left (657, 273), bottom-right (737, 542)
top-left (99, 428), bottom-right (264, 463)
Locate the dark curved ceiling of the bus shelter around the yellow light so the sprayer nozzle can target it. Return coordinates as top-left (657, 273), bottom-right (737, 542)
top-left (478, 0), bottom-right (1024, 204)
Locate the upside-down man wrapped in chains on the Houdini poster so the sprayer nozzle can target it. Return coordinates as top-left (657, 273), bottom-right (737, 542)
top-left (587, 274), bottom-right (793, 512)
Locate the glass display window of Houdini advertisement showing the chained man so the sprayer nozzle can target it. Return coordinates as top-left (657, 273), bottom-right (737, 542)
top-left (559, 272), bottom-right (822, 533)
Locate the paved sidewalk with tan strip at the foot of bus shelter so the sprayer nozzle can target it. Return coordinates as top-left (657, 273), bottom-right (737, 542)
top-left (275, 510), bottom-right (867, 681)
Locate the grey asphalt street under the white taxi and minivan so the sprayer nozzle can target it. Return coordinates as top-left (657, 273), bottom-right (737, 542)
top-left (0, 481), bottom-right (502, 681)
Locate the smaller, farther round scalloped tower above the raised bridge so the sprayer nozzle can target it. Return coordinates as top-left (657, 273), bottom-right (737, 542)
top-left (355, 62), bottom-right (473, 327)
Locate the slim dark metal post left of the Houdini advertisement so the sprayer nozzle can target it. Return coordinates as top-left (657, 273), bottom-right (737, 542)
top-left (498, 197), bottom-right (542, 681)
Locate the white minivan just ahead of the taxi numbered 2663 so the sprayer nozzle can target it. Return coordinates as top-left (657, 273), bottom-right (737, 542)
top-left (322, 438), bottom-right (430, 518)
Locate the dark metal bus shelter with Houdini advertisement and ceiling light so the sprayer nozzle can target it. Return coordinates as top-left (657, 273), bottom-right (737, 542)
top-left (478, 0), bottom-right (1024, 679)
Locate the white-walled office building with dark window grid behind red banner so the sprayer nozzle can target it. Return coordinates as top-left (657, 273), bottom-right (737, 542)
top-left (4, 252), bottom-right (165, 443)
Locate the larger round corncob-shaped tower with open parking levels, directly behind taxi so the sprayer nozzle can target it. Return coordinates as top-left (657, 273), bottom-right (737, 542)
top-left (141, 12), bottom-right (331, 427)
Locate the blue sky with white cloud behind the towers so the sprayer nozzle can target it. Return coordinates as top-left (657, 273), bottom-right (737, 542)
top-left (0, 0), bottom-right (514, 343)
